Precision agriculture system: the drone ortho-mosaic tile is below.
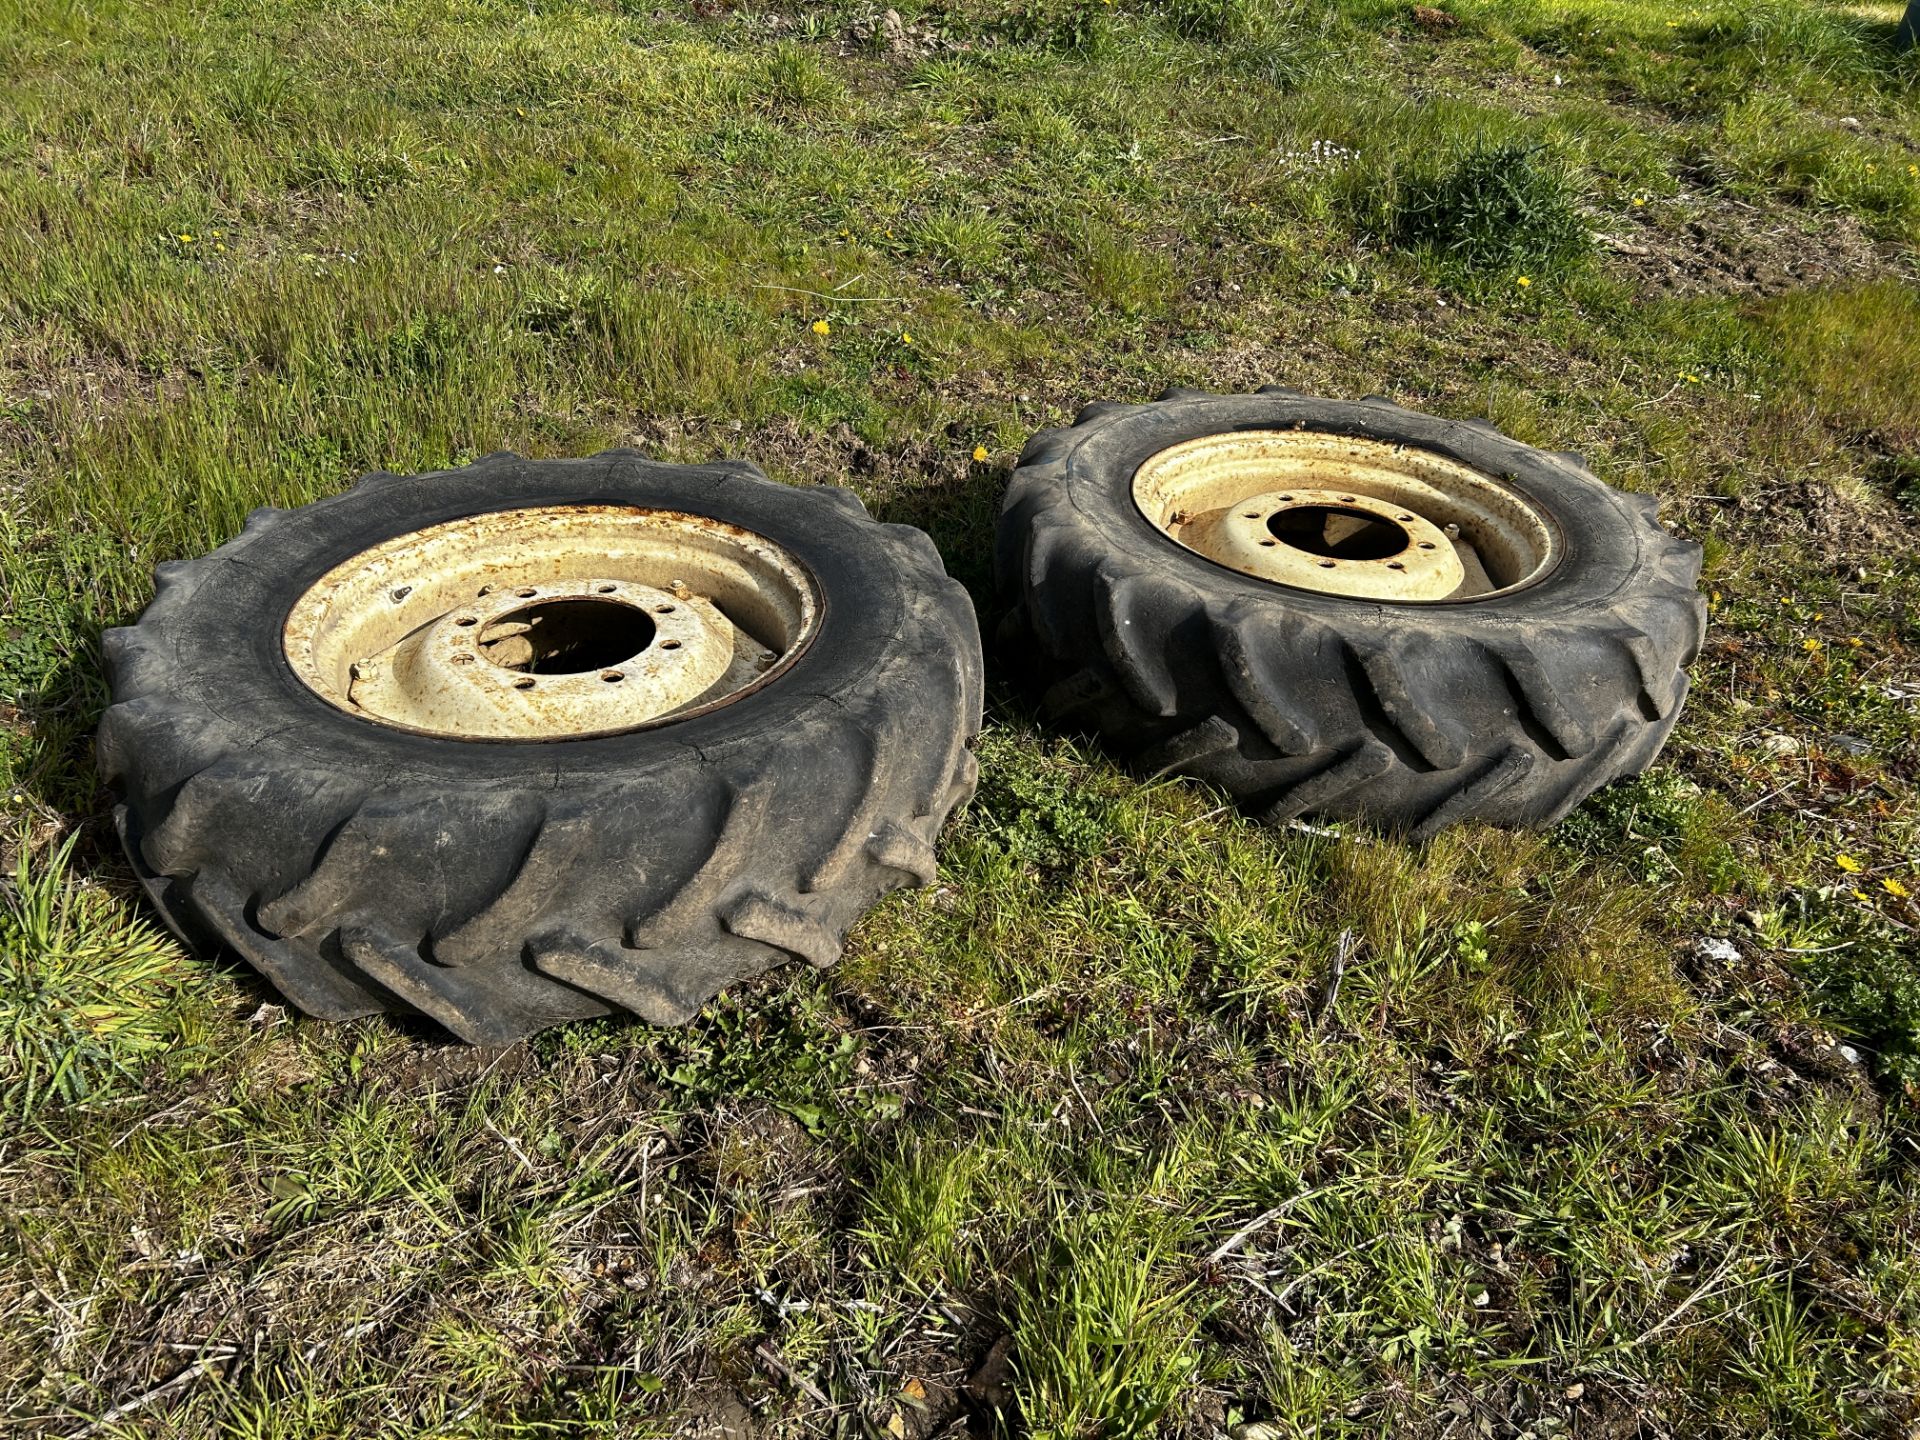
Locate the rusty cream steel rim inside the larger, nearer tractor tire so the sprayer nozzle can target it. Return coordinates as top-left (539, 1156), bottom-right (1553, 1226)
top-left (282, 505), bottom-right (822, 741)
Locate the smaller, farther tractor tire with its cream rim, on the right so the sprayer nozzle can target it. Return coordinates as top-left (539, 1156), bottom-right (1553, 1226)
top-left (995, 386), bottom-right (1707, 839)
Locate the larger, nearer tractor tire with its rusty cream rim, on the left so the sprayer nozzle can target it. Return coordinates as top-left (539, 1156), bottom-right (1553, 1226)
top-left (98, 451), bottom-right (981, 1046)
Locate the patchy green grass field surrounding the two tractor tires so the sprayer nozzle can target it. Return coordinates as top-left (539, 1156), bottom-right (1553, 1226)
top-left (0, 0), bottom-right (1920, 1440)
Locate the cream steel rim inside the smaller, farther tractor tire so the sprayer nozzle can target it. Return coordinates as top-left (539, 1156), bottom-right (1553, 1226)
top-left (1133, 430), bottom-right (1561, 603)
